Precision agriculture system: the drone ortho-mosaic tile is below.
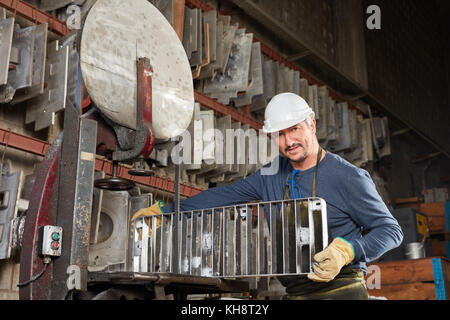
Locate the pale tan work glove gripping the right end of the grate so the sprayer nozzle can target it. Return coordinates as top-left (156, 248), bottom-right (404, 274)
top-left (308, 238), bottom-right (355, 282)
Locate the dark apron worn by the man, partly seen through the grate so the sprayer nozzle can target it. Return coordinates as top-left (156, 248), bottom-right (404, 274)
top-left (277, 147), bottom-right (369, 300)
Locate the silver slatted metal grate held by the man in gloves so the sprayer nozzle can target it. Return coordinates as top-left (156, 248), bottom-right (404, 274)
top-left (130, 198), bottom-right (328, 278)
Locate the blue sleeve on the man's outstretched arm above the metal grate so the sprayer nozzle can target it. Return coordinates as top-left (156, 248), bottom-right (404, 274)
top-left (163, 170), bottom-right (263, 213)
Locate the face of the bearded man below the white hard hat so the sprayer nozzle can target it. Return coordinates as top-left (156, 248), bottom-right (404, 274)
top-left (278, 120), bottom-right (316, 162)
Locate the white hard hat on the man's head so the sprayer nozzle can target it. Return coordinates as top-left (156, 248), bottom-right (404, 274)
top-left (263, 92), bottom-right (314, 133)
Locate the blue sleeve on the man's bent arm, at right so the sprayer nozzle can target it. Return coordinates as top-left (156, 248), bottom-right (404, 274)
top-left (343, 169), bottom-right (403, 262)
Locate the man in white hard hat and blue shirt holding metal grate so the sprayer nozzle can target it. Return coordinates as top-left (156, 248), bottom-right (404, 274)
top-left (133, 93), bottom-right (403, 299)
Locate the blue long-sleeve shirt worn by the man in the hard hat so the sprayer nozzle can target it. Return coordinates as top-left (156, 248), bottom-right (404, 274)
top-left (163, 151), bottom-right (403, 272)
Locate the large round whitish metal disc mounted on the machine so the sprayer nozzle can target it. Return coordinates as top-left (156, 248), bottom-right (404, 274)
top-left (80, 0), bottom-right (194, 139)
